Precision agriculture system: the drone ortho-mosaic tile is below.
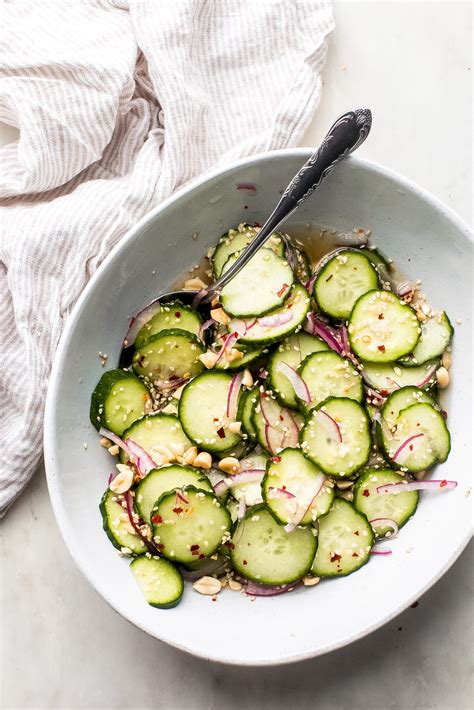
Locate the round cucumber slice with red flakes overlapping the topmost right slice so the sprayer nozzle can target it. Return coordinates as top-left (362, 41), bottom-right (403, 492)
top-left (348, 291), bottom-right (421, 362)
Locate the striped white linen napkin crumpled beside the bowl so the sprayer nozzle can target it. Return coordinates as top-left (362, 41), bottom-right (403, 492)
top-left (0, 0), bottom-right (333, 516)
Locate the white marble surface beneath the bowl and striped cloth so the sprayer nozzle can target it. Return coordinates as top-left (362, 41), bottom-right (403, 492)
top-left (0, 1), bottom-right (473, 710)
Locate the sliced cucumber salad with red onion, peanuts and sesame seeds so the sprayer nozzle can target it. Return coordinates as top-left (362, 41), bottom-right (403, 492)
top-left (91, 224), bottom-right (456, 608)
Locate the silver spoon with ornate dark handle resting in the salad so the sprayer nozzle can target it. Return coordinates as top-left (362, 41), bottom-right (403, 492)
top-left (121, 109), bottom-right (372, 368)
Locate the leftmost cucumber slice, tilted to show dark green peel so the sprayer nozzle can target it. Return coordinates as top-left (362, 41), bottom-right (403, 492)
top-left (90, 370), bottom-right (151, 436)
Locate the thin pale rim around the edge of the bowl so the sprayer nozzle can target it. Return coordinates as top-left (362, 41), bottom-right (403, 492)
top-left (43, 152), bottom-right (474, 667)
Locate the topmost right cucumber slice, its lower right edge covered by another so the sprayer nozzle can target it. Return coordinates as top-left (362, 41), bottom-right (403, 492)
top-left (313, 250), bottom-right (379, 320)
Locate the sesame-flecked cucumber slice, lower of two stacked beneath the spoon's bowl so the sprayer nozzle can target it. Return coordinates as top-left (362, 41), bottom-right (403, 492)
top-left (132, 330), bottom-right (205, 383)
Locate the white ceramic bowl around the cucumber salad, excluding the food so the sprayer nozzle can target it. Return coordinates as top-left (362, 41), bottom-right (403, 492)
top-left (45, 149), bottom-right (473, 665)
